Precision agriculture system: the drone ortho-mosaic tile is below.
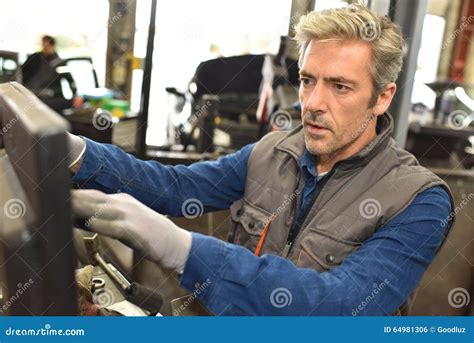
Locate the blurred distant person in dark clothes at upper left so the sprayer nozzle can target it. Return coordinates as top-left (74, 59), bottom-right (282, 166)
top-left (21, 36), bottom-right (83, 113)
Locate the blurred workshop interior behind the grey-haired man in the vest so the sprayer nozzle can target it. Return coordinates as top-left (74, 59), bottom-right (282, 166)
top-left (0, 0), bottom-right (474, 316)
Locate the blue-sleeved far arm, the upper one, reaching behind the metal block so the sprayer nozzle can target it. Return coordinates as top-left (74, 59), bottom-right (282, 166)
top-left (73, 139), bottom-right (253, 216)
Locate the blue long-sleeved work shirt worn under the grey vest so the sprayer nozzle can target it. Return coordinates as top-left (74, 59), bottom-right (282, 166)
top-left (74, 140), bottom-right (451, 316)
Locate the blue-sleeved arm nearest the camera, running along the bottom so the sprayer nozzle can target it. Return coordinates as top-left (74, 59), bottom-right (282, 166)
top-left (181, 187), bottom-right (451, 315)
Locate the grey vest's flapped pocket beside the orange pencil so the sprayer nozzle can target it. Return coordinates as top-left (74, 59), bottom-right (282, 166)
top-left (228, 199), bottom-right (271, 251)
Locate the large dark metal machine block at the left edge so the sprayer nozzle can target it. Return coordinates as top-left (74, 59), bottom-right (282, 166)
top-left (0, 82), bottom-right (77, 315)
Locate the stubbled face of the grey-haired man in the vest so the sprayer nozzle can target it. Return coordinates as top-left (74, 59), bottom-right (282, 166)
top-left (299, 39), bottom-right (375, 159)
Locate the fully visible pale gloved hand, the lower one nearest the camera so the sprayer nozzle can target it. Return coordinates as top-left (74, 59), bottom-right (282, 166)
top-left (72, 190), bottom-right (192, 272)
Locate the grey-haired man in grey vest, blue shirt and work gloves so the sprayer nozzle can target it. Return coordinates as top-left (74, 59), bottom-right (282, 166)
top-left (65, 6), bottom-right (453, 315)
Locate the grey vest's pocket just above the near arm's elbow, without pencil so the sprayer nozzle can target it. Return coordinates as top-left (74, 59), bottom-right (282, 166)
top-left (293, 229), bottom-right (362, 271)
